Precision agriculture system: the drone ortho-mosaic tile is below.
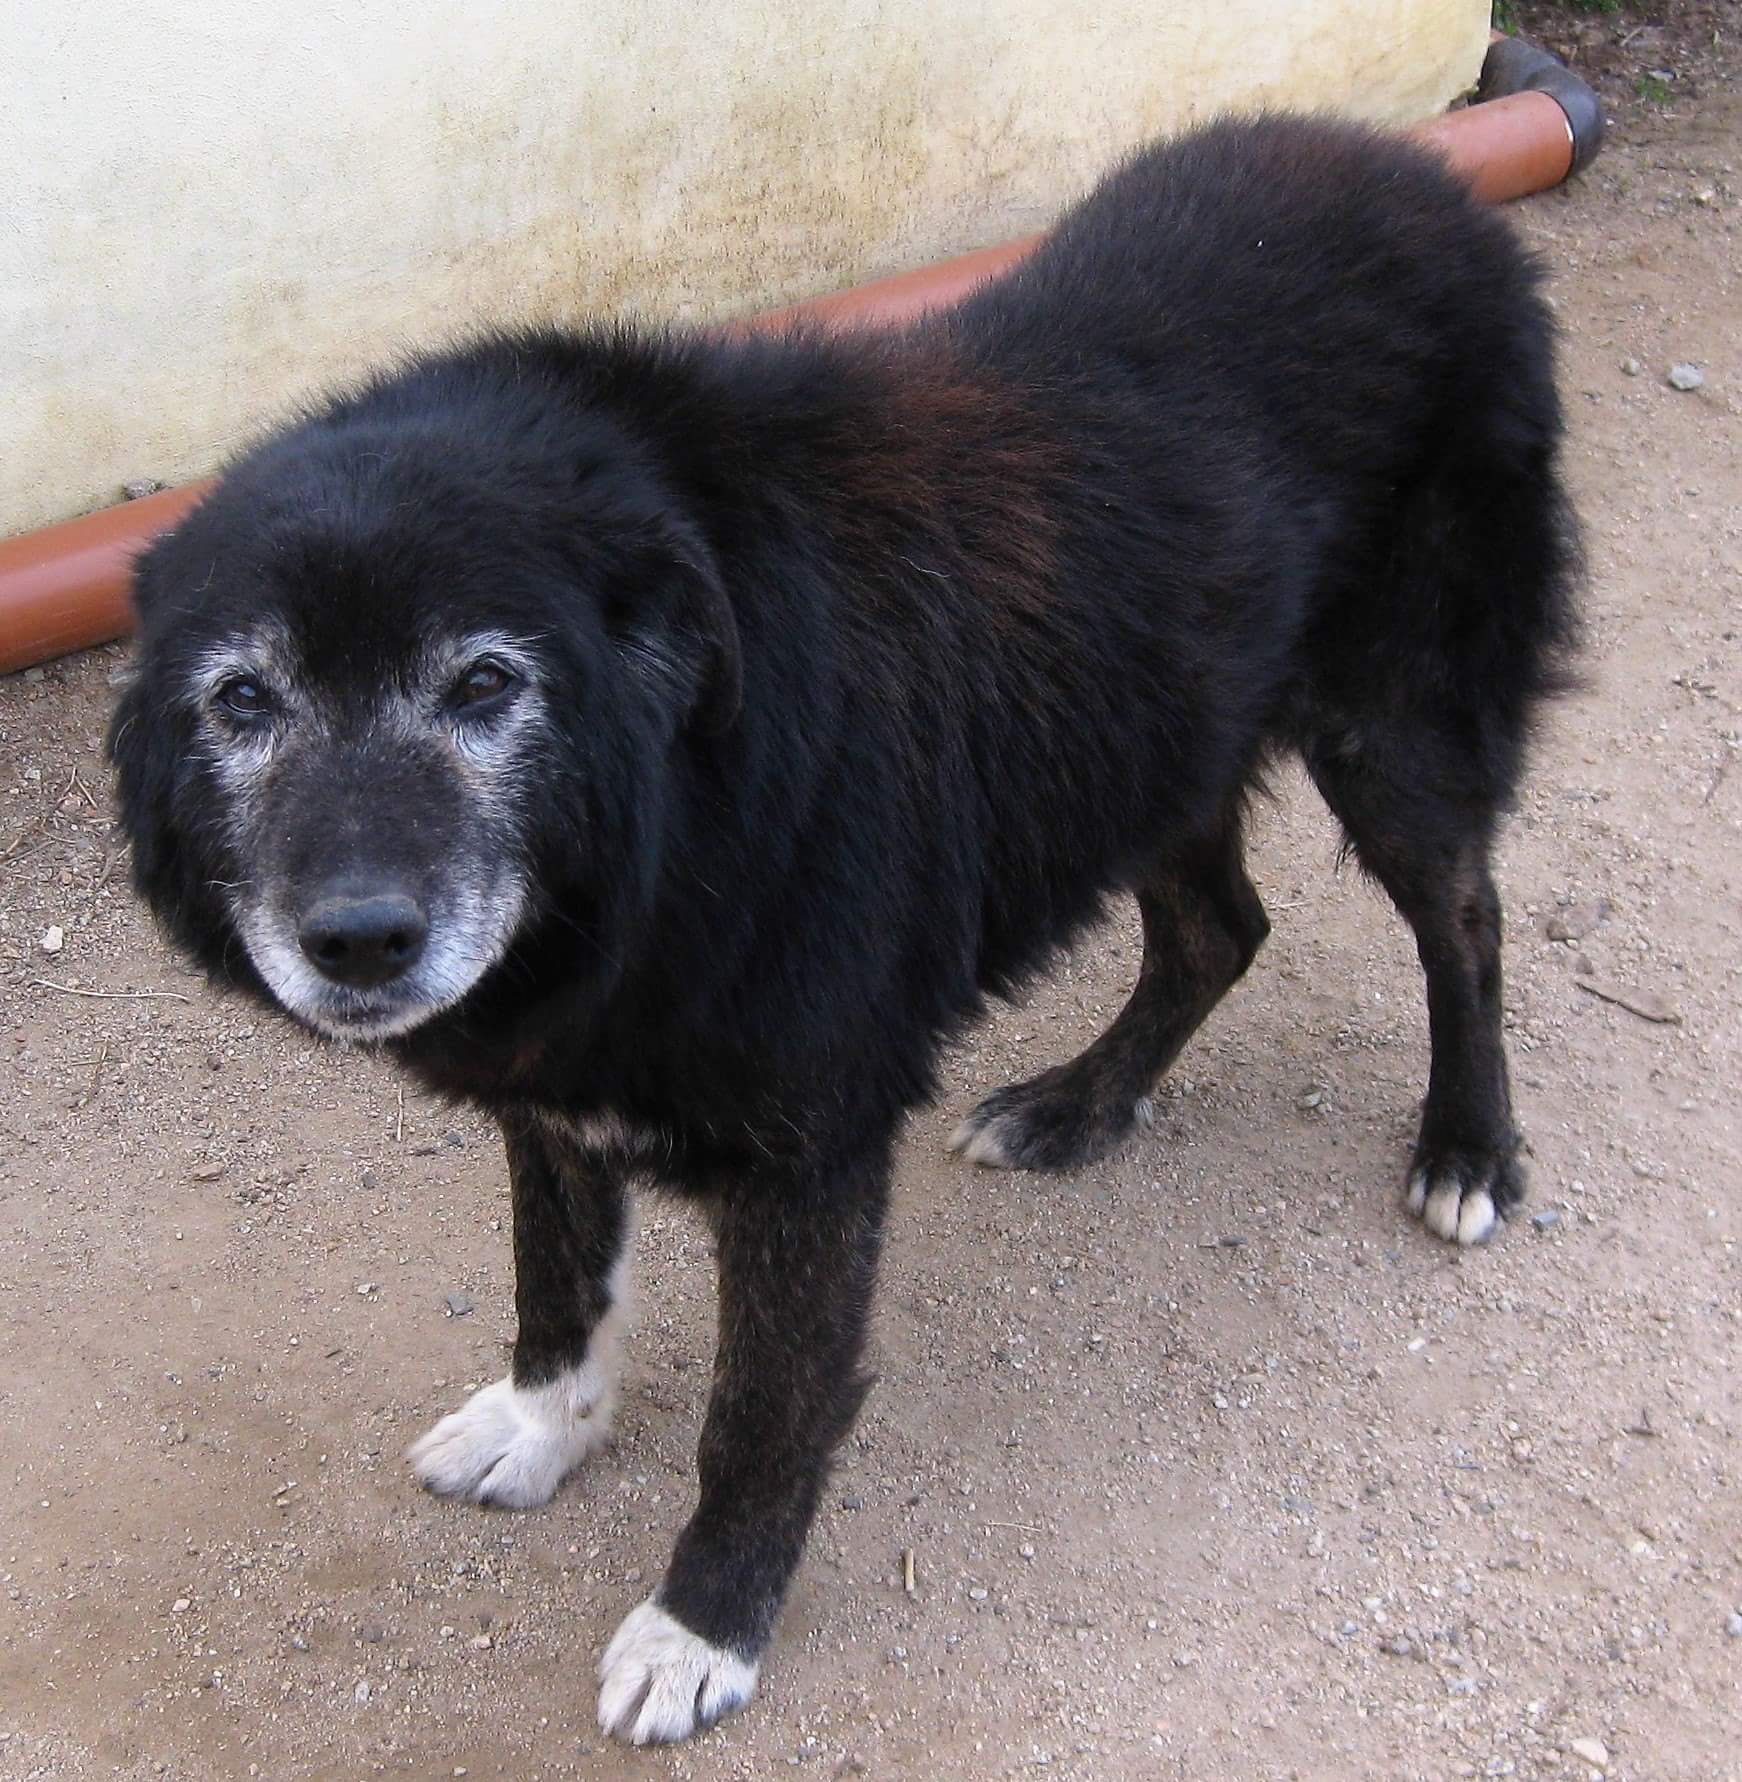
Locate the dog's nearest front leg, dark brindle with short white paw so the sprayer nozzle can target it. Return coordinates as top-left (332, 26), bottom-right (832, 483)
top-left (598, 1149), bottom-right (889, 1745)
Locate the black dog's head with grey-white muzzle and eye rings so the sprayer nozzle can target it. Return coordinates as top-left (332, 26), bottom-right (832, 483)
top-left (110, 365), bottom-right (737, 1041)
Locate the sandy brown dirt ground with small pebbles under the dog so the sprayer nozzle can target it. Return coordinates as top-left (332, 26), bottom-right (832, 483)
top-left (0, 27), bottom-right (1742, 1782)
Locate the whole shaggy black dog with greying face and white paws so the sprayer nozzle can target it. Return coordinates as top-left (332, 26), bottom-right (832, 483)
top-left (112, 118), bottom-right (1573, 1741)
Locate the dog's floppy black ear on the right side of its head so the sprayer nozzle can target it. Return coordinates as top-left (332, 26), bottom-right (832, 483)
top-left (607, 519), bottom-right (745, 736)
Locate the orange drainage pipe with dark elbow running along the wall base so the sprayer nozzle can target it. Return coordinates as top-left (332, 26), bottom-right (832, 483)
top-left (0, 37), bottom-right (1603, 674)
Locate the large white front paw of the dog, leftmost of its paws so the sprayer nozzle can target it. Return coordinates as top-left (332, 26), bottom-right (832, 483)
top-left (406, 1367), bottom-right (616, 1509)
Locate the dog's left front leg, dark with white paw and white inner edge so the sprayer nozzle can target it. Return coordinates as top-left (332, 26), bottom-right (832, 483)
top-left (408, 1114), bottom-right (629, 1509)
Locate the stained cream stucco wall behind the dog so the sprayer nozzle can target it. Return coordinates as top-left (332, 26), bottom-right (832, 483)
top-left (0, 0), bottom-right (1489, 533)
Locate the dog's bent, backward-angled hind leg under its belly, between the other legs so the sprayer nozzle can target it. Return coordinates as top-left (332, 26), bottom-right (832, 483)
top-left (949, 816), bottom-right (1270, 1169)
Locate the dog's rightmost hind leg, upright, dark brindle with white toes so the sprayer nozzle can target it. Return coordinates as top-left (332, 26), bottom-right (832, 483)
top-left (1307, 722), bottom-right (1525, 1244)
